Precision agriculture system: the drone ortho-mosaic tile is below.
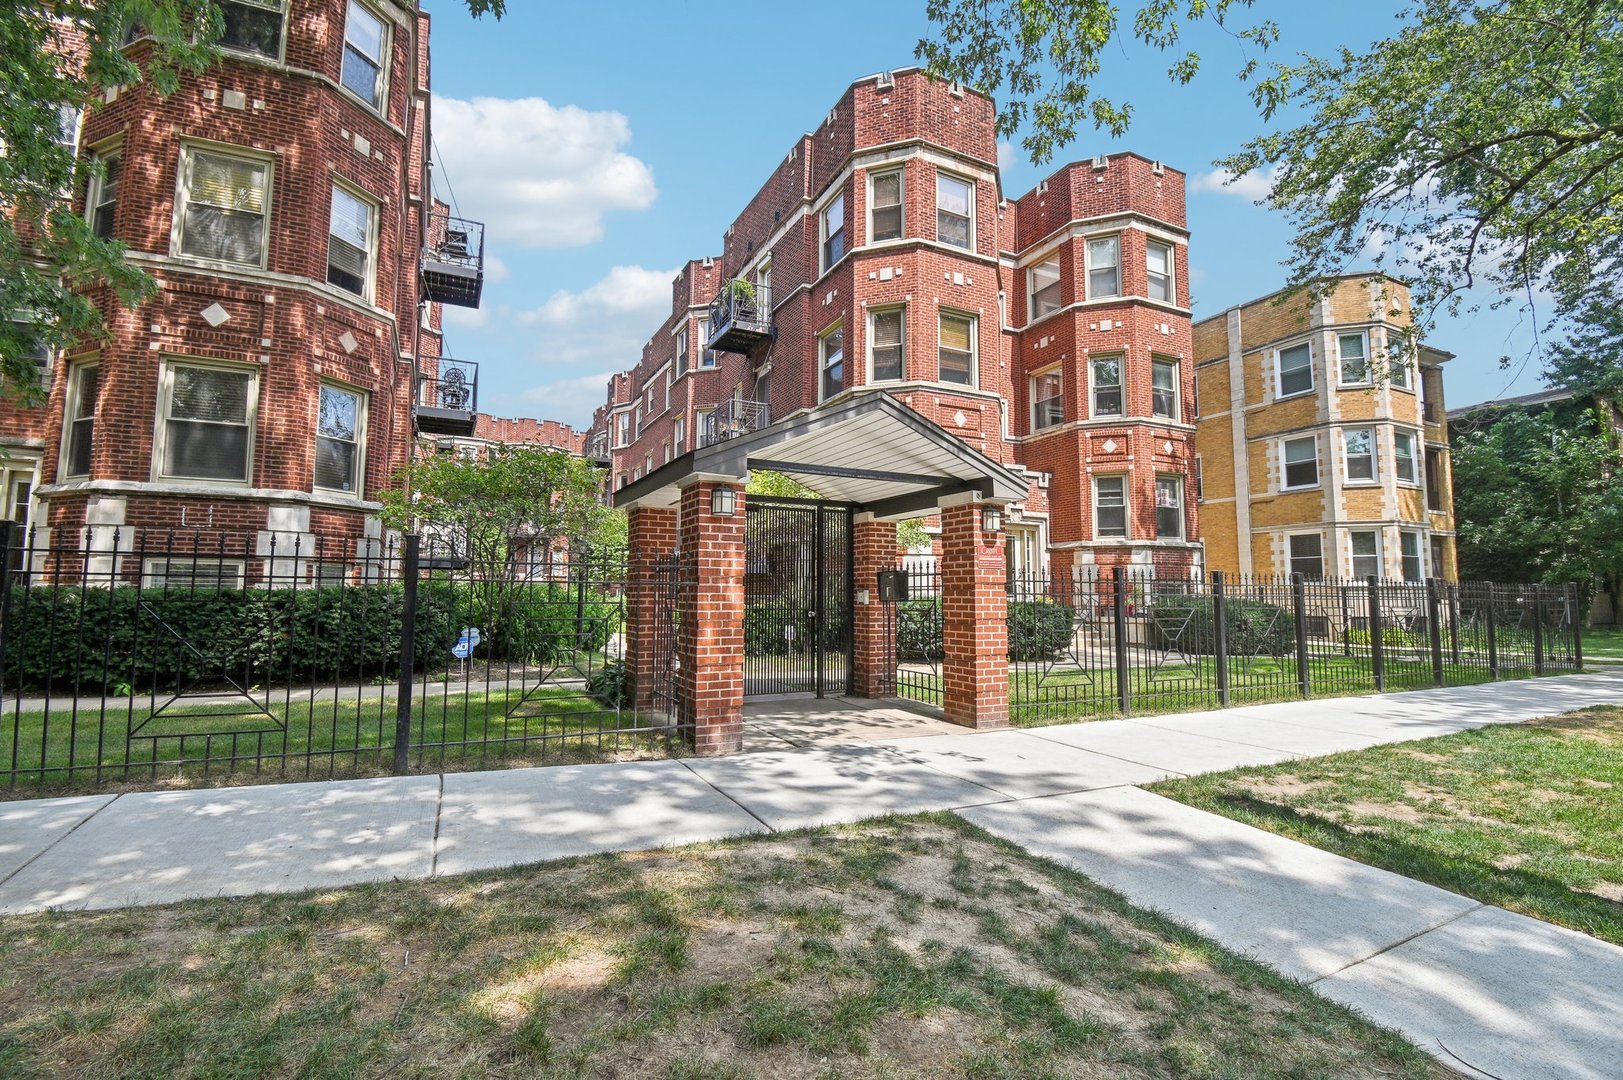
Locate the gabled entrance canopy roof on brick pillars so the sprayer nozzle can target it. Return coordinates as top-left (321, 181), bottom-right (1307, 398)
top-left (613, 393), bottom-right (1027, 520)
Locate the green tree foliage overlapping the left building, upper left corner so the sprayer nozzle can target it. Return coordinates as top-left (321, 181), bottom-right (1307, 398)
top-left (0, 0), bottom-right (505, 401)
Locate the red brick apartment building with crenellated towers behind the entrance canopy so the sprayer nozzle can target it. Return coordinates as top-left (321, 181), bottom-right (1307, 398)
top-left (588, 70), bottom-right (1201, 578)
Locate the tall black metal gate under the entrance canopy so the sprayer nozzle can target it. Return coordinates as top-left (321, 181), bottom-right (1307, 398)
top-left (743, 495), bottom-right (852, 697)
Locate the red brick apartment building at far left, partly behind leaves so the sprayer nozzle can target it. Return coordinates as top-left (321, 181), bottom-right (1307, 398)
top-left (0, 0), bottom-right (484, 583)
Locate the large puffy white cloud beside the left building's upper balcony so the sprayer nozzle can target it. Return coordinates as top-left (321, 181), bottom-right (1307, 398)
top-left (433, 94), bottom-right (657, 247)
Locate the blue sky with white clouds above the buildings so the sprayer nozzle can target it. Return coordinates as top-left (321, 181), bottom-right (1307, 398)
top-left (432, 0), bottom-right (1540, 426)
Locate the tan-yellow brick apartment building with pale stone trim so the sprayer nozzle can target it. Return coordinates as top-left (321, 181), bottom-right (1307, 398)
top-left (1195, 274), bottom-right (1457, 580)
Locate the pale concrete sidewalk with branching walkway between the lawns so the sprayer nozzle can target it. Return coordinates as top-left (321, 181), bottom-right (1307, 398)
top-left (0, 672), bottom-right (1623, 1080)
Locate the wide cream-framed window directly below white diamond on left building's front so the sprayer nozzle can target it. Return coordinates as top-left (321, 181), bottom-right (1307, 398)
top-left (159, 364), bottom-right (258, 484)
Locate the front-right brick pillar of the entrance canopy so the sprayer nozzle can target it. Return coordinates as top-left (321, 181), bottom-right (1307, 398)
top-left (941, 502), bottom-right (1010, 728)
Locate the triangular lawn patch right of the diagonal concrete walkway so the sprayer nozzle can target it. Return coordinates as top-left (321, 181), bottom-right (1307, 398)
top-left (1152, 706), bottom-right (1623, 945)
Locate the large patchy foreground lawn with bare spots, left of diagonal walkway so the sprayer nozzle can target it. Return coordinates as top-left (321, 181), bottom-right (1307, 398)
top-left (0, 815), bottom-right (1453, 1080)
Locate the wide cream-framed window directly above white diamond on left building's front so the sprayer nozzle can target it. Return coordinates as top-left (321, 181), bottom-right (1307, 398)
top-left (180, 146), bottom-right (271, 266)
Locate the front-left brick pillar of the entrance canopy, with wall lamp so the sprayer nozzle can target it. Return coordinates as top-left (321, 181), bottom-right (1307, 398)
top-left (677, 481), bottom-right (743, 754)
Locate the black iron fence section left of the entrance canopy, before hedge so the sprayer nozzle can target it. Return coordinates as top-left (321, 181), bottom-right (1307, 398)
top-left (0, 525), bottom-right (691, 786)
